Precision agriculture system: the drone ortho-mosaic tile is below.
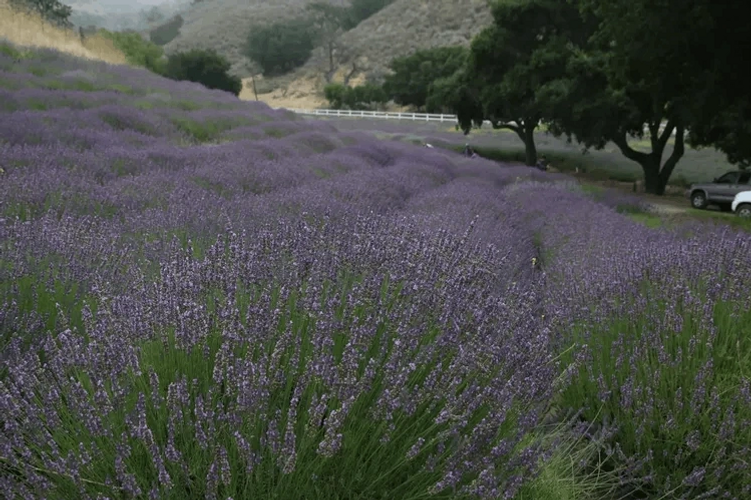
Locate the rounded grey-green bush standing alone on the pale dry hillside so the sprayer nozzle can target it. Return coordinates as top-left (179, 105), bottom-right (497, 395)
top-left (245, 19), bottom-right (315, 75)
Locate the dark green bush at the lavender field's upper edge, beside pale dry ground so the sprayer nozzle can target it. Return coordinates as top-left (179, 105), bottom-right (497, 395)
top-left (164, 49), bottom-right (242, 95)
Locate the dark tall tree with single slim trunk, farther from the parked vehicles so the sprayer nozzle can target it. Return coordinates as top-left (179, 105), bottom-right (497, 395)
top-left (429, 0), bottom-right (588, 165)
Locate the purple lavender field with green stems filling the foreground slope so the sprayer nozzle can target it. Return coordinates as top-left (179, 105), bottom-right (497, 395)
top-left (0, 44), bottom-right (751, 500)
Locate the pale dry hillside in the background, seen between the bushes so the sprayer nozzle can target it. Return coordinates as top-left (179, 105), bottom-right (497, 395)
top-left (165, 0), bottom-right (490, 97)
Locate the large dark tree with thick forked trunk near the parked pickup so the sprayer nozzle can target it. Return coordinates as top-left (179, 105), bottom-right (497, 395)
top-left (538, 0), bottom-right (732, 194)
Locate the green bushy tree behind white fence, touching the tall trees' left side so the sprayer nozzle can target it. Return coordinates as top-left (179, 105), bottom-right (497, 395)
top-left (383, 47), bottom-right (468, 108)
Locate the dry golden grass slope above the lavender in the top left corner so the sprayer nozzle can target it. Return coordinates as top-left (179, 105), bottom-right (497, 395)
top-left (0, 0), bottom-right (127, 64)
